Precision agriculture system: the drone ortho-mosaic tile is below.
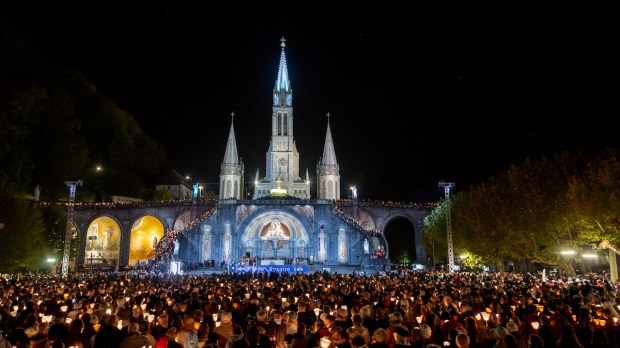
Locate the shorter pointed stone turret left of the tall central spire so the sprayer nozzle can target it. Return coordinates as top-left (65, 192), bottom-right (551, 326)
top-left (220, 112), bottom-right (243, 199)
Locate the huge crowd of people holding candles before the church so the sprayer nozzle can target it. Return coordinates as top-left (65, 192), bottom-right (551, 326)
top-left (0, 270), bottom-right (620, 348)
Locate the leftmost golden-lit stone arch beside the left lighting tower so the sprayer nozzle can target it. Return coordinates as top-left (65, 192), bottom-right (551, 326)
top-left (83, 215), bottom-right (123, 266)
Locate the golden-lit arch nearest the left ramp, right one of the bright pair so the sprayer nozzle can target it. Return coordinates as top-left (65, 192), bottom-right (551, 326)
top-left (128, 215), bottom-right (165, 265)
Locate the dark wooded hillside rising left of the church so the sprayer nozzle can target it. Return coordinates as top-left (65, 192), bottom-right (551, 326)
top-left (0, 16), bottom-right (166, 201)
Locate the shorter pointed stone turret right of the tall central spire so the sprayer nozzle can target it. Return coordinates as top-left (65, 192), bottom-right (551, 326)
top-left (318, 112), bottom-right (340, 200)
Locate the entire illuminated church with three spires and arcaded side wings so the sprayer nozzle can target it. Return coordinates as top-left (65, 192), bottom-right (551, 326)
top-left (73, 39), bottom-right (430, 267)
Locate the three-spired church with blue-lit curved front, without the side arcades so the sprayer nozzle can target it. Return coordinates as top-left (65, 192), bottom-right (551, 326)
top-left (181, 39), bottom-right (376, 265)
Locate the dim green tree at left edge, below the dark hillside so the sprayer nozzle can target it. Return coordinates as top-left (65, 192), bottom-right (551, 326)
top-left (0, 174), bottom-right (45, 273)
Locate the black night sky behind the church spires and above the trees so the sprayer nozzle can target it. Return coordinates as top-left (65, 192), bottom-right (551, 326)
top-left (4, 2), bottom-right (620, 201)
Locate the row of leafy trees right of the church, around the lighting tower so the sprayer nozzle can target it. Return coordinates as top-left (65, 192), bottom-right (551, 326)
top-left (425, 149), bottom-right (620, 273)
